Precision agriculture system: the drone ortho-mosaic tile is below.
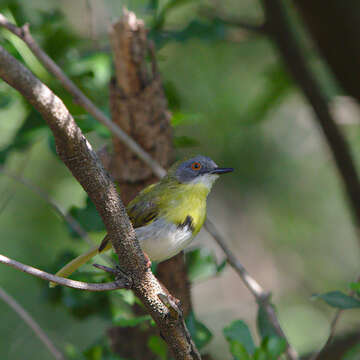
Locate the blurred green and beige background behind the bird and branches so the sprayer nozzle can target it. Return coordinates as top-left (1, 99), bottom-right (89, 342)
top-left (0, 0), bottom-right (360, 360)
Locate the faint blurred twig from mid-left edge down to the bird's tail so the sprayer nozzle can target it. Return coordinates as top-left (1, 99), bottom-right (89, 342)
top-left (0, 166), bottom-right (114, 265)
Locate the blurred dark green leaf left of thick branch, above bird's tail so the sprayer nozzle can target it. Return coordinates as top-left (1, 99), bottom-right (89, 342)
top-left (69, 198), bottom-right (105, 238)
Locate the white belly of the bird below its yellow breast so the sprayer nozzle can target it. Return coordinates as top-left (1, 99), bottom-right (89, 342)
top-left (135, 219), bottom-right (193, 261)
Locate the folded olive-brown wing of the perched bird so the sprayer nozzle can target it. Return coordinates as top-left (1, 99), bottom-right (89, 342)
top-left (126, 184), bottom-right (160, 228)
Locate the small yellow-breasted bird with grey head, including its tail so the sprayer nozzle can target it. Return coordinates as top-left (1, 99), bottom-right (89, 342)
top-left (51, 155), bottom-right (233, 285)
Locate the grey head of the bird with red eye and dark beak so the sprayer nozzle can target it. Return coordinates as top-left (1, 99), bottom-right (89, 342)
top-left (173, 155), bottom-right (233, 188)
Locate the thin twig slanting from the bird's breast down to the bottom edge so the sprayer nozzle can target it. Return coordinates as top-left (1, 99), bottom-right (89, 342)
top-left (205, 219), bottom-right (298, 360)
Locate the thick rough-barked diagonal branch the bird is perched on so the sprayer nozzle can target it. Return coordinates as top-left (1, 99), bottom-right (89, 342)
top-left (0, 46), bottom-right (200, 360)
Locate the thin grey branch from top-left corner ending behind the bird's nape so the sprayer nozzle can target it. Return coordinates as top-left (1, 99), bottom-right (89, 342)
top-left (0, 14), bottom-right (166, 178)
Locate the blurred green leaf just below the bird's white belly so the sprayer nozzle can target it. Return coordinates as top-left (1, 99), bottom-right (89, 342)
top-left (185, 248), bottom-right (218, 282)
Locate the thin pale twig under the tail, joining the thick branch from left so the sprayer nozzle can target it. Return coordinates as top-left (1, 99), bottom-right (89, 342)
top-left (0, 255), bottom-right (130, 291)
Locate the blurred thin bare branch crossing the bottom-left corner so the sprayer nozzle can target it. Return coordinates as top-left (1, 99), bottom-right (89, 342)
top-left (0, 286), bottom-right (65, 360)
